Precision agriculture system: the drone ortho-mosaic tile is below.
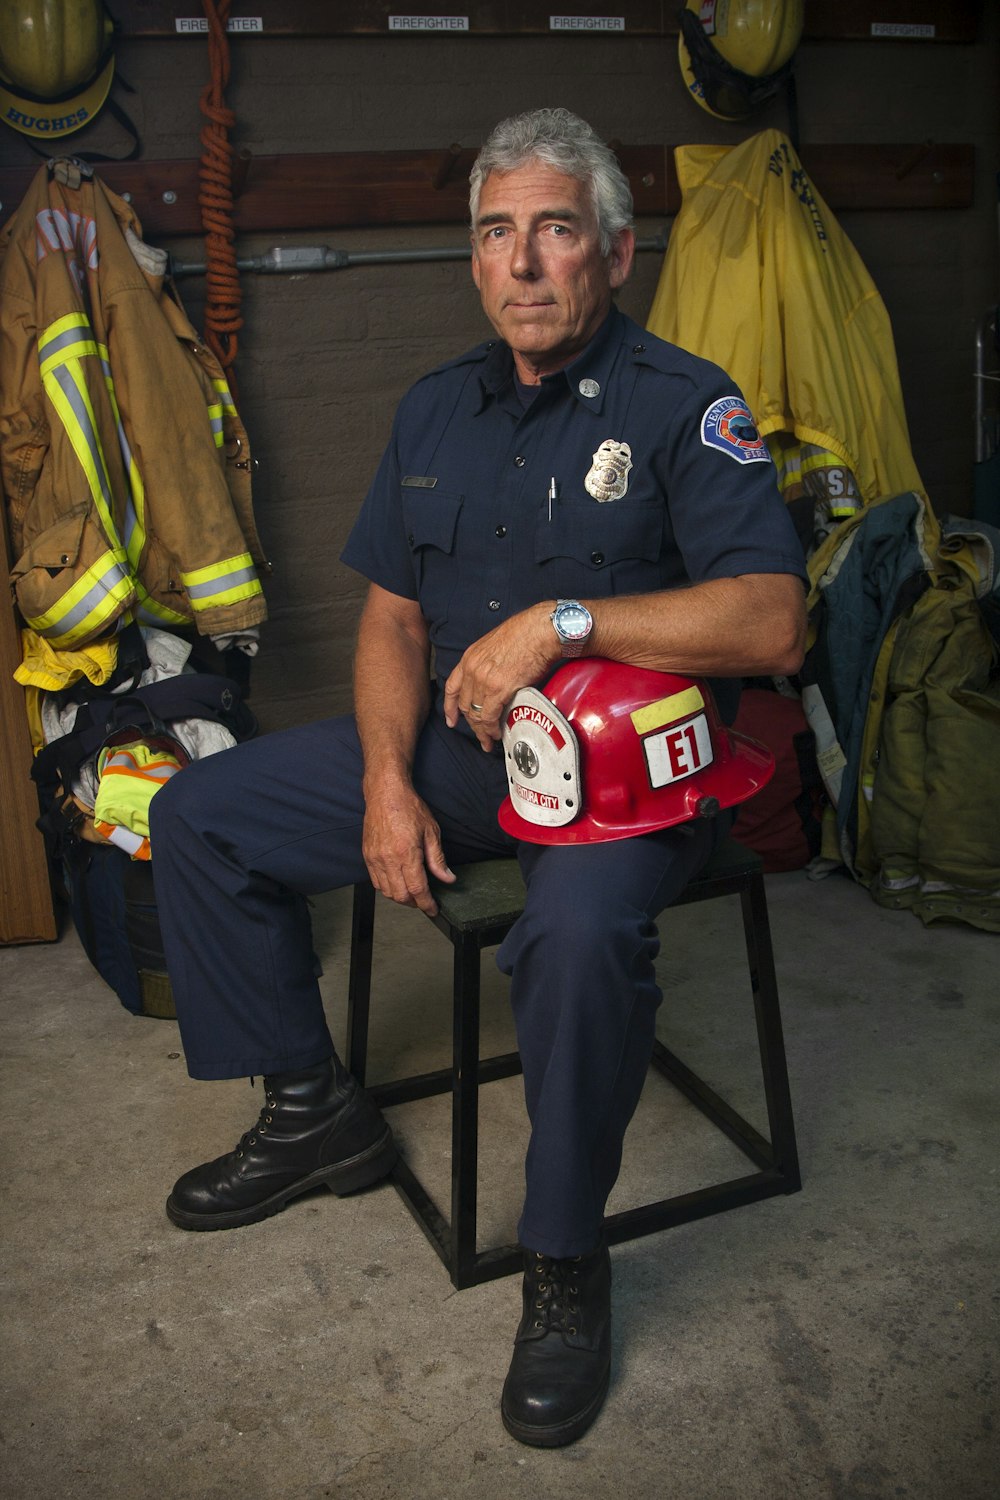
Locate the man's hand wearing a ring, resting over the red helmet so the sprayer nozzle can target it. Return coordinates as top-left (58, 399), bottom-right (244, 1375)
top-left (444, 603), bottom-right (559, 750)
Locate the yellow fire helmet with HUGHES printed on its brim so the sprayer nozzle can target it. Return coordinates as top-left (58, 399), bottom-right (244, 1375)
top-left (0, 0), bottom-right (114, 141)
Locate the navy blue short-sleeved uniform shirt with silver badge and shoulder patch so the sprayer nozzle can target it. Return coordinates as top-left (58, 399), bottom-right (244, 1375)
top-left (342, 308), bottom-right (807, 719)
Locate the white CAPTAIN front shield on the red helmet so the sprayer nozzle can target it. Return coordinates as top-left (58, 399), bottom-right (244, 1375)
top-left (502, 687), bottom-right (580, 828)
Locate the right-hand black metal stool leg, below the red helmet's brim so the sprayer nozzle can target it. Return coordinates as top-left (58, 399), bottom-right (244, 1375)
top-left (739, 875), bottom-right (802, 1193)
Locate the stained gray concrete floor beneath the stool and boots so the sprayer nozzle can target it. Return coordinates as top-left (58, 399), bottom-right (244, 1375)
top-left (0, 873), bottom-right (1000, 1500)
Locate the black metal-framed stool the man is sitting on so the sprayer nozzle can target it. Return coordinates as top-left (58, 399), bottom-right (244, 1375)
top-left (346, 839), bottom-right (802, 1289)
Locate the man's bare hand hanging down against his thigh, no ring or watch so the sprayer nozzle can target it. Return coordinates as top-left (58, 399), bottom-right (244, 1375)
top-left (361, 782), bottom-right (454, 917)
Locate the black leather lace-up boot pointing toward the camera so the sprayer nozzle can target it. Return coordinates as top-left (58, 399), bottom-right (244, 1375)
top-left (501, 1244), bottom-right (612, 1448)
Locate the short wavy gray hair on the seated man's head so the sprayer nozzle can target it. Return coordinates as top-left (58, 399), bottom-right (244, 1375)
top-left (469, 110), bottom-right (633, 255)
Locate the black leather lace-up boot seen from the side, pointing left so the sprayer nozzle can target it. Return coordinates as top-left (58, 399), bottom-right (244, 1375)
top-left (166, 1058), bottom-right (396, 1229)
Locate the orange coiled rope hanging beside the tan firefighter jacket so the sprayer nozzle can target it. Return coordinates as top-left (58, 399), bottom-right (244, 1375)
top-left (198, 0), bottom-right (243, 401)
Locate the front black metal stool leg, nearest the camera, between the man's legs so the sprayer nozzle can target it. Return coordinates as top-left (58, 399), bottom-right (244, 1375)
top-left (450, 933), bottom-right (481, 1289)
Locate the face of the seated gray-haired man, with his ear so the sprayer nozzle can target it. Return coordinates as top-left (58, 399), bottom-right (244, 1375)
top-left (472, 162), bottom-right (636, 386)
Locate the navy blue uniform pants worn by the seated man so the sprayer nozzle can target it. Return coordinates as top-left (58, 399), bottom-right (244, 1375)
top-left (150, 714), bottom-right (715, 1256)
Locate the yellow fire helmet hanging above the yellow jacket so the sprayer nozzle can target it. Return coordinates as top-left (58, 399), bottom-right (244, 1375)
top-left (678, 0), bottom-right (804, 120)
